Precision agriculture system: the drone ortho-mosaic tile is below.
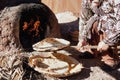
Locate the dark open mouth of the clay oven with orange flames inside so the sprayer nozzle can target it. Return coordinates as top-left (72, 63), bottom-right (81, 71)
top-left (20, 9), bottom-right (47, 51)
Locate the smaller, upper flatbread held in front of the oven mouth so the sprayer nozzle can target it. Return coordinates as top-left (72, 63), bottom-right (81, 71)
top-left (32, 38), bottom-right (70, 51)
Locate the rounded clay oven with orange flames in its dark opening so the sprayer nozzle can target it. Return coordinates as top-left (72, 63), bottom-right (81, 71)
top-left (0, 0), bottom-right (60, 53)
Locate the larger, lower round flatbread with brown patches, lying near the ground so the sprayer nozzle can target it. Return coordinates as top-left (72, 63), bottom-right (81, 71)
top-left (29, 53), bottom-right (83, 77)
